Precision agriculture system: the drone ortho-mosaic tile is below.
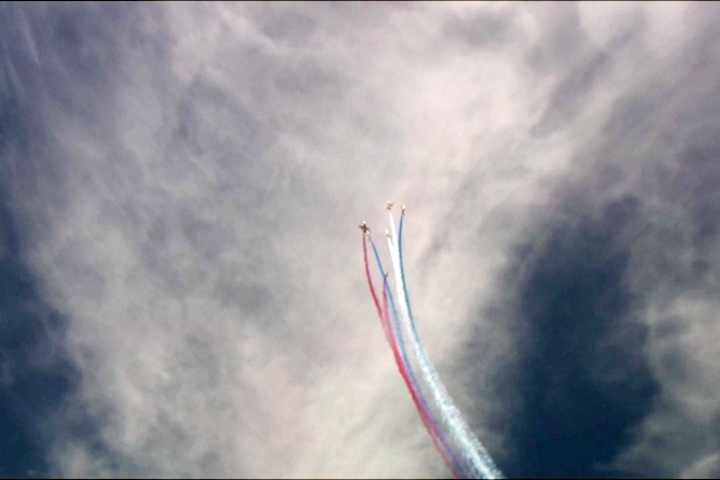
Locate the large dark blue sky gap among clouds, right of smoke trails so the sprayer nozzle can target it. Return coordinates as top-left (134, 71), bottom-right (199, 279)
top-left (496, 197), bottom-right (658, 477)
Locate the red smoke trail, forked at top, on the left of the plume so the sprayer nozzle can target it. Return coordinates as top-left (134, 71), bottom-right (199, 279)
top-left (363, 233), bottom-right (462, 478)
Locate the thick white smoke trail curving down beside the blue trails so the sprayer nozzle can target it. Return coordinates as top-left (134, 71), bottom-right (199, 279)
top-left (387, 207), bottom-right (502, 478)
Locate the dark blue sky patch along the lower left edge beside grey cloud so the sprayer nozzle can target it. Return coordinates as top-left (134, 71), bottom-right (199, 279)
top-left (0, 201), bottom-right (80, 478)
